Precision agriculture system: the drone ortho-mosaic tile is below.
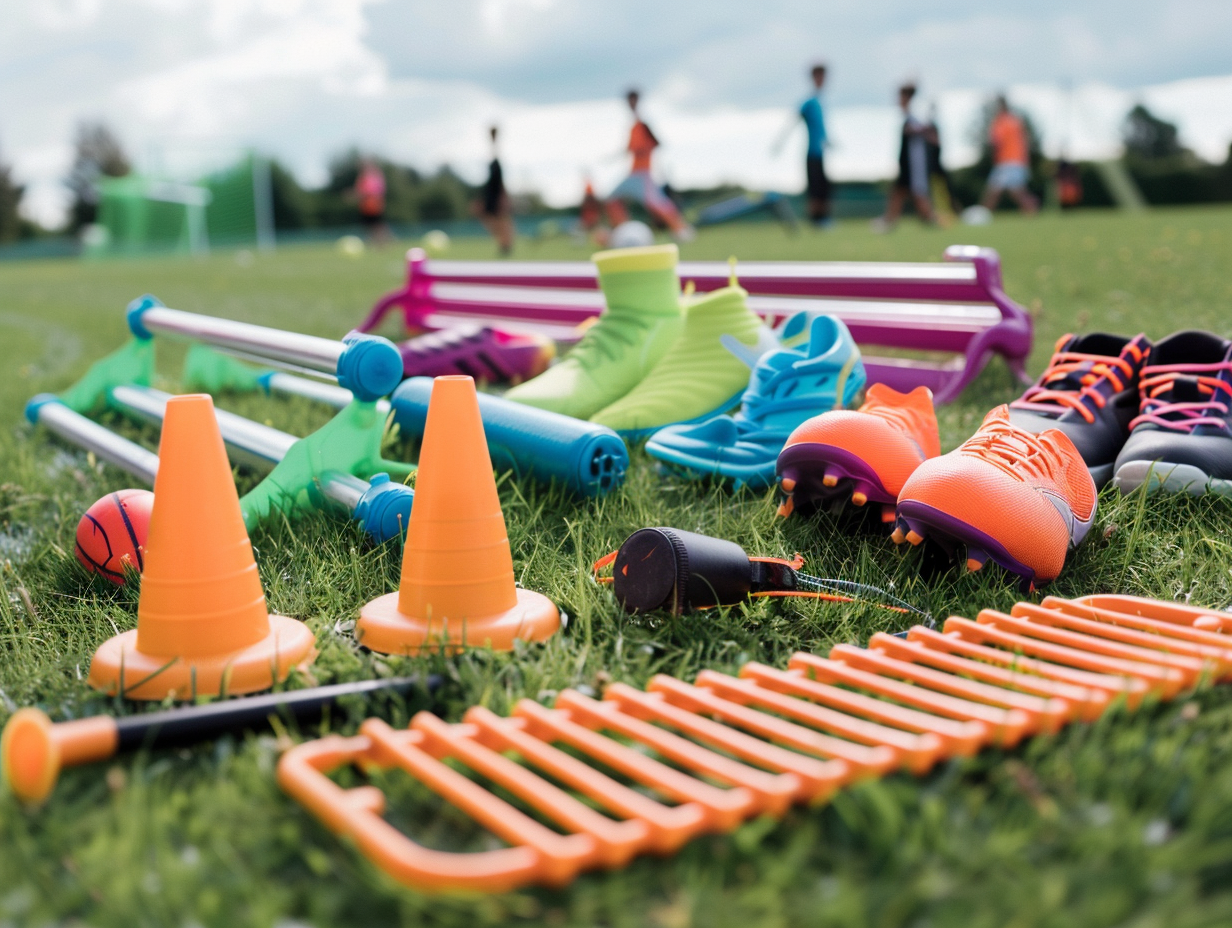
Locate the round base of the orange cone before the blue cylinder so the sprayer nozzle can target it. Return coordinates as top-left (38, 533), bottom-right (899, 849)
top-left (355, 589), bottom-right (561, 654)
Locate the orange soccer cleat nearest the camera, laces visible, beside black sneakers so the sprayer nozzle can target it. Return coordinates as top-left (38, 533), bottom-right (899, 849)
top-left (893, 405), bottom-right (1095, 589)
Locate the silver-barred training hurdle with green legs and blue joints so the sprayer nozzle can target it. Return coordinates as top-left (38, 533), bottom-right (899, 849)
top-left (26, 296), bottom-right (414, 534)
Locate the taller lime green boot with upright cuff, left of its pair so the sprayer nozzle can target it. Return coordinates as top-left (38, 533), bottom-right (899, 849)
top-left (505, 245), bottom-right (689, 419)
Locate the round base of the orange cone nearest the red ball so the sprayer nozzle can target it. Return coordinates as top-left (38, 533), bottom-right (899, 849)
top-left (89, 615), bottom-right (317, 700)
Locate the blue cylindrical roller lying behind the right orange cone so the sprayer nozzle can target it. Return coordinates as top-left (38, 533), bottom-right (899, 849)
top-left (391, 377), bottom-right (628, 497)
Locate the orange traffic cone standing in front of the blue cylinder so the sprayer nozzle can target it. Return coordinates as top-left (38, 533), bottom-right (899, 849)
top-left (355, 376), bottom-right (561, 654)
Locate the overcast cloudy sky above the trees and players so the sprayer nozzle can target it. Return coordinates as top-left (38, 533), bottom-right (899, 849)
top-left (0, 0), bottom-right (1232, 221)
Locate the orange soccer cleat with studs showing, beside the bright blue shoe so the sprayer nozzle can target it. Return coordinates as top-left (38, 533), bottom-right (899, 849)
top-left (777, 383), bottom-right (941, 523)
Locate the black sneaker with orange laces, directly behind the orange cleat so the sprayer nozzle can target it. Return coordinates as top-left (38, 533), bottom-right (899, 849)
top-left (1009, 332), bottom-right (1151, 487)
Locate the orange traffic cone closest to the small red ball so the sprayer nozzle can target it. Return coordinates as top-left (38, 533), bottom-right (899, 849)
top-left (90, 394), bottom-right (315, 700)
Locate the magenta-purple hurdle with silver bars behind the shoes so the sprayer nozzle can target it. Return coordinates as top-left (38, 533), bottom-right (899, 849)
top-left (360, 245), bottom-right (1032, 403)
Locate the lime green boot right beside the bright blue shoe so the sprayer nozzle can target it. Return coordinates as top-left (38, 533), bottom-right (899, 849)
top-left (590, 285), bottom-right (781, 440)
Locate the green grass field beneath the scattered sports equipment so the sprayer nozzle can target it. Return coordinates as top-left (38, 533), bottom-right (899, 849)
top-left (0, 208), bottom-right (1232, 928)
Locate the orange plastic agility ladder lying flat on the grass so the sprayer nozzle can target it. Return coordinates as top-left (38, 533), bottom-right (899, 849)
top-left (278, 595), bottom-right (1232, 892)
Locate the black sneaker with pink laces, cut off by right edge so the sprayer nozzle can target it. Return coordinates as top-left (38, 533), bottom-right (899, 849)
top-left (1112, 332), bottom-right (1232, 495)
